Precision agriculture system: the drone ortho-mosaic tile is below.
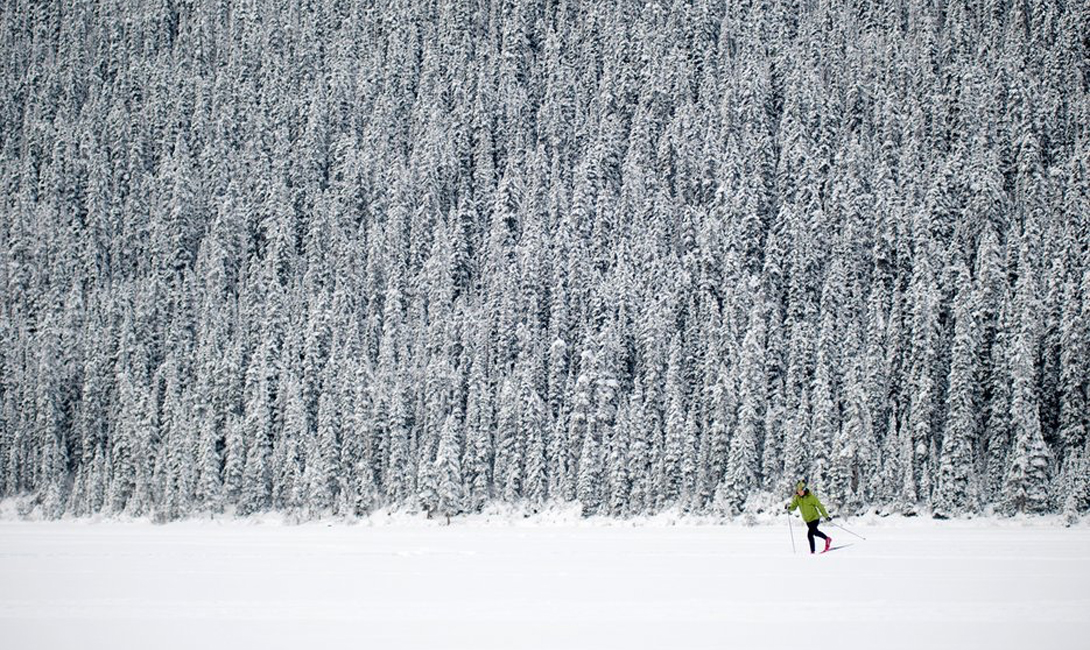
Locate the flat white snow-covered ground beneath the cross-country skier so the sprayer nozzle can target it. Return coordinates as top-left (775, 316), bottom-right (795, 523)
top-left (0, 512), bottom-right (1090, 650)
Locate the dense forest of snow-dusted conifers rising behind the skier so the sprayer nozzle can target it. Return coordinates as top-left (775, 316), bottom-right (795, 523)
top-left (0, 0), bottom-right (1090, 520)
